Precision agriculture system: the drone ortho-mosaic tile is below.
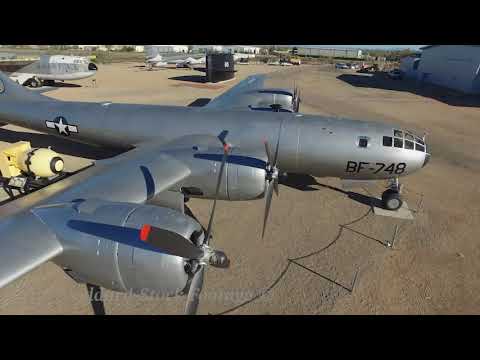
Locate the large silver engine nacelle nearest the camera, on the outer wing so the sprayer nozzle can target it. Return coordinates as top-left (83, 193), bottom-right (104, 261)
top-left (33, 200), bottom-right (203, 296)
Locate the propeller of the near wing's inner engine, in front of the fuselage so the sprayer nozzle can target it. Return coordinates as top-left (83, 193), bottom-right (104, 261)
top-left (262, 120), bottom-right (283, 238)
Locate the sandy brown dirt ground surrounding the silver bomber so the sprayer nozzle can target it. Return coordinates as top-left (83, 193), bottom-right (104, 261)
top-left (0, 63), bottom-right (480, 314)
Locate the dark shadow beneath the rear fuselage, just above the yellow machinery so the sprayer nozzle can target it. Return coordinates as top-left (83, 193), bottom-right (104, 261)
top-left (0, 128), bottom-right (127, 160)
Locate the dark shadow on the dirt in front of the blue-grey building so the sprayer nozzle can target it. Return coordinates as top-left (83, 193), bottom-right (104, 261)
top-left (337, 72), bottom-right (480, 107)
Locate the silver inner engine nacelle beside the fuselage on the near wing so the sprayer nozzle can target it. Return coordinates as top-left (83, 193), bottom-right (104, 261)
top-left (169, 147), bottom-right (266, 201)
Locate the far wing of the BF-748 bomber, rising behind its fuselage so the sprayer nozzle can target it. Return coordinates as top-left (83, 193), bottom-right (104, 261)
top-left (204, 75), bottom-right (266, 110)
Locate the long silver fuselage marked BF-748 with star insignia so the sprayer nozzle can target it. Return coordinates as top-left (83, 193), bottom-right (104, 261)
top-left (0, 101), bottom-right (428, 180)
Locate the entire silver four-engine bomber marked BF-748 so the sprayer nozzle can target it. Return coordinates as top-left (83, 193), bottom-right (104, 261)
top-left (0, 69), bottom-right (431, 314)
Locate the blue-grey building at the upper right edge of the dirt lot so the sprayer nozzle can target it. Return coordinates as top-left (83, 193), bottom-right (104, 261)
top-left (417, 45), bottom-right (480, 94)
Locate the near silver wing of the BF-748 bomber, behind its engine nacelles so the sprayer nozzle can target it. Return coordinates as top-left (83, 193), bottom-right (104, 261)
top-left (0, 141), bottom-right (190, 288)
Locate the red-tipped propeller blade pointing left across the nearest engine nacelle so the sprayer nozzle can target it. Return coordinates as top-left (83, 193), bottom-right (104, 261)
top-left (140, 224), bottom-right (204, 259)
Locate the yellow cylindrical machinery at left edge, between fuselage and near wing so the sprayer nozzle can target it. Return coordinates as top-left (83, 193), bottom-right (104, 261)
top-left (0, 141), bottom-right (64, 178)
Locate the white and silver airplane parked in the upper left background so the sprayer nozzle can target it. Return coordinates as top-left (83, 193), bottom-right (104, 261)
top-left (4, 55), bottom-right (98, 88)
